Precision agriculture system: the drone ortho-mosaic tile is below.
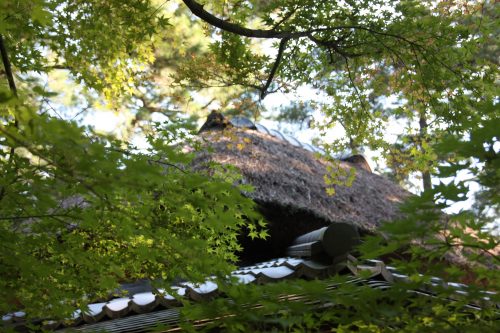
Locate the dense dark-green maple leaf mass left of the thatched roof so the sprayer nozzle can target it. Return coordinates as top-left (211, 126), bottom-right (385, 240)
top-left (0, 95), bottom-right (262, 319)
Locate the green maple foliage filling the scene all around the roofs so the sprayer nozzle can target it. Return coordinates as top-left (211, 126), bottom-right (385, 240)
top-left (0, 0), bottom-right (500, 332)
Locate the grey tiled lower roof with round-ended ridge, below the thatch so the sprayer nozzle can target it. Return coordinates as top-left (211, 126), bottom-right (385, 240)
top-left (0, 224), bottom-right (488, 332)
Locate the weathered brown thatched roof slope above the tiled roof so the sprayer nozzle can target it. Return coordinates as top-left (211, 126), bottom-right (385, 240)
top-left (194, 116), bottom-right (410, 260)
